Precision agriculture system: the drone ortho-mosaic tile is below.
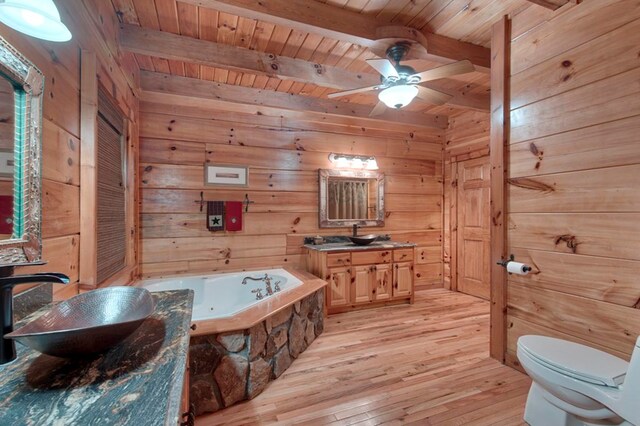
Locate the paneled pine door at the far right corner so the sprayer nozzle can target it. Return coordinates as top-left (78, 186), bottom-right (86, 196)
top-left (456, 157), bottom-right (491, 299)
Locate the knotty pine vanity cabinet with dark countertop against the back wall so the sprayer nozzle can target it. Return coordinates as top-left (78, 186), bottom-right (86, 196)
top-left (304, 241), bottom-right (415, 314)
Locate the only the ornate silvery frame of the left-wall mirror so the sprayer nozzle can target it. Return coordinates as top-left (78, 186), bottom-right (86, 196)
top-left (0, 37), bottom-right (44, 266)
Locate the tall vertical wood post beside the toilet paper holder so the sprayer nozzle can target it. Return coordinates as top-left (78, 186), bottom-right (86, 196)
top-left (489, 16), bottom-right (511, 363)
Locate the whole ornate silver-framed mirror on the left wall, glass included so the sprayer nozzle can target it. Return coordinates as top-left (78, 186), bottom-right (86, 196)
top-left (0, 38), bottom-right (44, 266)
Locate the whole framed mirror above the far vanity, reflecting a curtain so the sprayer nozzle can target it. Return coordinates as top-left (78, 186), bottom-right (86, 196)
top-left (319, 169), bottom-right (384, 228)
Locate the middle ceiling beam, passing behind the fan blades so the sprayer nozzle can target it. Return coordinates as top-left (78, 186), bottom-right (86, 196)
top-left (119, 24), bottom-right (489, 111)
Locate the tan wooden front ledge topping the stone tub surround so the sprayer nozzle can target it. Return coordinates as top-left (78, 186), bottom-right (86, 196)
top-left (186, 267), bottom-right (327, 336)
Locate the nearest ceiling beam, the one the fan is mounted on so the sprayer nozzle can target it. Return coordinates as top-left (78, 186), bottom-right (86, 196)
top-left (181, 0), bottom-right (491, 71)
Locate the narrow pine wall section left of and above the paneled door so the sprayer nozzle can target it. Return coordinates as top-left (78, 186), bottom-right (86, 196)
top-left (442, 111), bottom-right (489, 290)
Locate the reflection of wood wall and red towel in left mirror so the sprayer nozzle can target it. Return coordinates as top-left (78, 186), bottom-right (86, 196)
top-left (0, 76), bottom-right (16, 240)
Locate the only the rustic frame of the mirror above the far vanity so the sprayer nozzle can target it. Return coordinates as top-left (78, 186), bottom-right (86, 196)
top-left (318, 169), bottom-right (385, 228)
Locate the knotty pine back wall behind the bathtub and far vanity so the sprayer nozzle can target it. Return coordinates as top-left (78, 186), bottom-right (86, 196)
top-left (140, 97), bottom-right (445, 287)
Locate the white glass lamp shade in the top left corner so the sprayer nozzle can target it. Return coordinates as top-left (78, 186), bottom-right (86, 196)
top-left (0, 0), bottom-right (71, 42)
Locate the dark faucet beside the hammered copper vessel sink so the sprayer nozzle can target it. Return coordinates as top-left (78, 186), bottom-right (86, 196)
top-left (0, 266), bottom-right (69, 365)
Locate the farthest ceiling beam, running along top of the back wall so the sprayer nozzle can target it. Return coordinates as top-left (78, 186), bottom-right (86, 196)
top-left (140, 71), bottom-right (448, 130)
